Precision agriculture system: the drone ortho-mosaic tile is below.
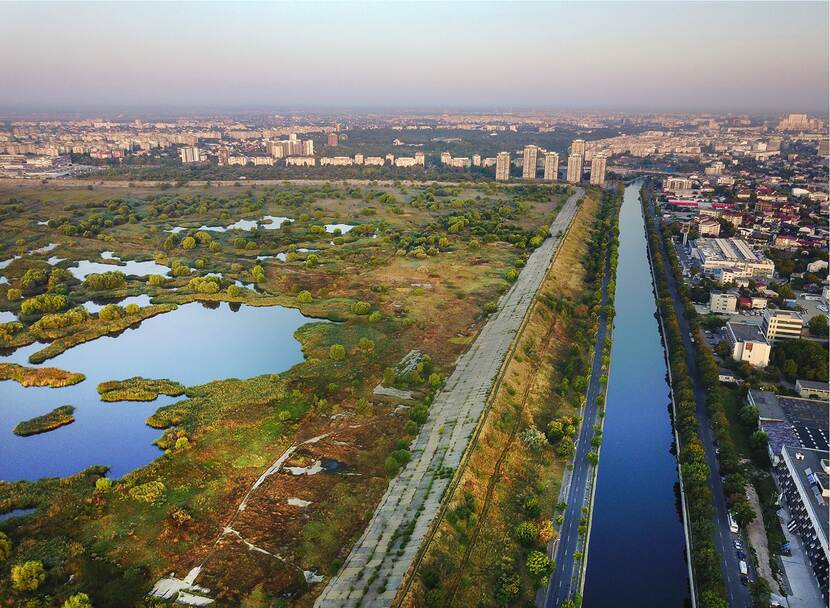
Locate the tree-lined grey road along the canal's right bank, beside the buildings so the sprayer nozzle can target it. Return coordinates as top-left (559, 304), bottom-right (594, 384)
top-left (649, 192), bottom-right (755, 608)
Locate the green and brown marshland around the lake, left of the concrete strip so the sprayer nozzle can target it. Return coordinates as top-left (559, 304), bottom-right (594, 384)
top-left (0, 178), bottom-right (572, 608)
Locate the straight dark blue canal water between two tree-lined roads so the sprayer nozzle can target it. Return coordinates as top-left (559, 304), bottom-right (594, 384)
top-left (583, 182), bottom-right (689, 608)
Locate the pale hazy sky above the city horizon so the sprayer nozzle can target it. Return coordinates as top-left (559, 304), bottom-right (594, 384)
top-left (0, 2), bottom-right (830, 113)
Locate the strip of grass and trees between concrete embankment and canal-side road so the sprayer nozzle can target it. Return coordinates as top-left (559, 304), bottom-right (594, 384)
top-left (404, 191), bottom-right (618, 606)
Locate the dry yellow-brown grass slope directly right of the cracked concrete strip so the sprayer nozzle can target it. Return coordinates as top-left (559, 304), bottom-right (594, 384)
top-left (404, 191), bottom-right (598, 606)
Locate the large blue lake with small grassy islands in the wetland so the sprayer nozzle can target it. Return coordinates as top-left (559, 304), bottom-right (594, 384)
top-left (0, 303), bottom-right (322, 481)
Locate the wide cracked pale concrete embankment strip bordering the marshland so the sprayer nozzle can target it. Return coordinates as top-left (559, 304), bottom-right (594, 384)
top-left (314, 188), bottom-right (584, 608)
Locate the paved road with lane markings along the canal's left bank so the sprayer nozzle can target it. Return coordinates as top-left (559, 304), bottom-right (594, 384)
top-left (536, 201), bottom-right (611, 608)
